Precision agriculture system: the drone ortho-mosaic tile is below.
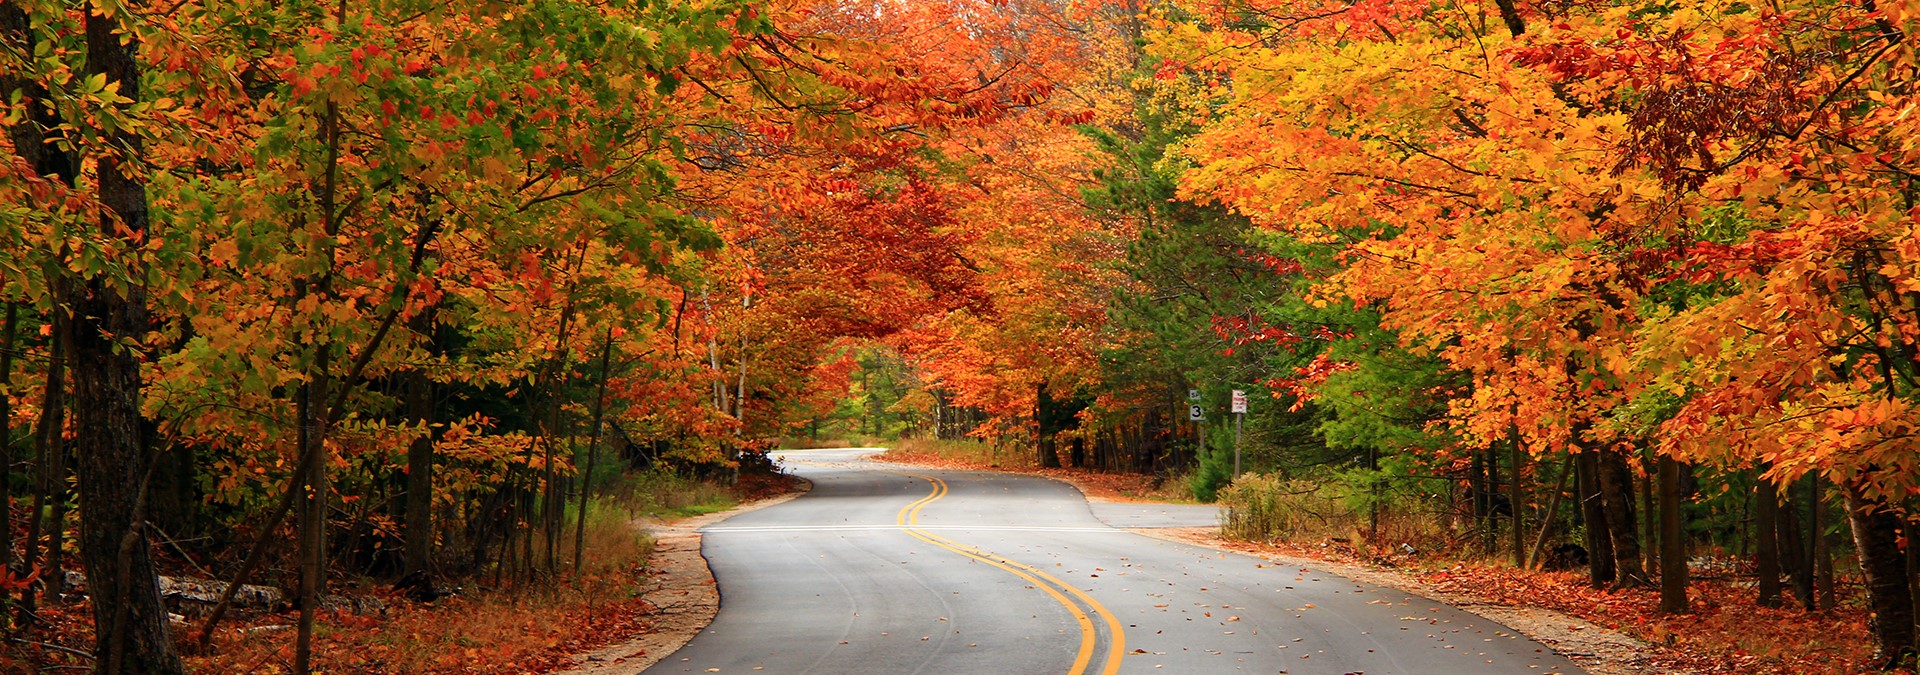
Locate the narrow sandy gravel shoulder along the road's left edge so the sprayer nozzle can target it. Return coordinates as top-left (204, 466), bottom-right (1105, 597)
top-left (559, 474), bottom-right (814, 675)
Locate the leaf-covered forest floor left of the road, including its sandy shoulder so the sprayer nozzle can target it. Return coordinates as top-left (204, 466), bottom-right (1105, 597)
top-left (0, 469), bottom-right (804, 673)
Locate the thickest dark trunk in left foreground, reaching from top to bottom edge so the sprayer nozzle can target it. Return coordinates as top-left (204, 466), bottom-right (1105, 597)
top-left (67, 6), bottom-right (184, 673)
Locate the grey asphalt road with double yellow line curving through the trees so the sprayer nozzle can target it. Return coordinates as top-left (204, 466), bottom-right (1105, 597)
top-left (647, 449), bottom-right (1580, 675)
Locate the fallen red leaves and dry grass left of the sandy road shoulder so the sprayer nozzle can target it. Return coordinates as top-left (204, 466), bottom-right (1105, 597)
top-left (142, 470), bottom-right (789, 673)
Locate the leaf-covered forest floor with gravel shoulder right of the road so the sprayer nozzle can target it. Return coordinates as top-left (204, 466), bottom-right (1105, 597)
top-left (876, 451), bottom-right (1878, 675)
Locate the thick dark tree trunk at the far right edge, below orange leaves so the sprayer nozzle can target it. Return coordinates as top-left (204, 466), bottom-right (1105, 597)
top-left (1843, 485), bottom-right (1914, 667)
